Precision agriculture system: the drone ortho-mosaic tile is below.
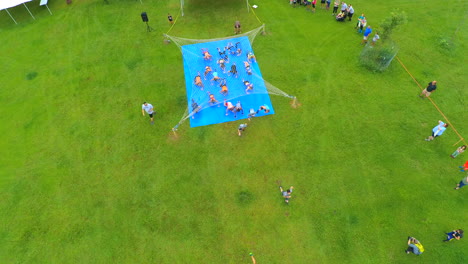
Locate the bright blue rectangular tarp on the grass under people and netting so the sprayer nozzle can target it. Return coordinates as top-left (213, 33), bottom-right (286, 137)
top-left (182, 37), bottom-right (274, 127)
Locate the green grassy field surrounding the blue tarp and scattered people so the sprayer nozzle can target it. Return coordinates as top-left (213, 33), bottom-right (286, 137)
top-left (0, 0), bottom-right (468, 264)
